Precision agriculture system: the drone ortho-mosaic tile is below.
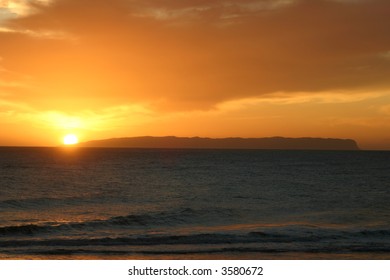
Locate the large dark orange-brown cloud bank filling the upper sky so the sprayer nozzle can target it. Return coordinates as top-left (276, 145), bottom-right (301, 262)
top-left (0, 0), bottom-right (390, 109)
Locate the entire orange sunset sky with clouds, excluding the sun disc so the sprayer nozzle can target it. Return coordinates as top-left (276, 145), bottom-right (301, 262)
top-left (0, 0), bottom-right (390, 149)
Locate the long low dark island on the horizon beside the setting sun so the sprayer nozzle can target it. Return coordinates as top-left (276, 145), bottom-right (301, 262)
top-left (78, 136), bottom-right (359, 150)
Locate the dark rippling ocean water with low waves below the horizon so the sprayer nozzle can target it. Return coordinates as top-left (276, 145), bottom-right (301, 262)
top-left (0, 148), bottom-right (390, 259)
